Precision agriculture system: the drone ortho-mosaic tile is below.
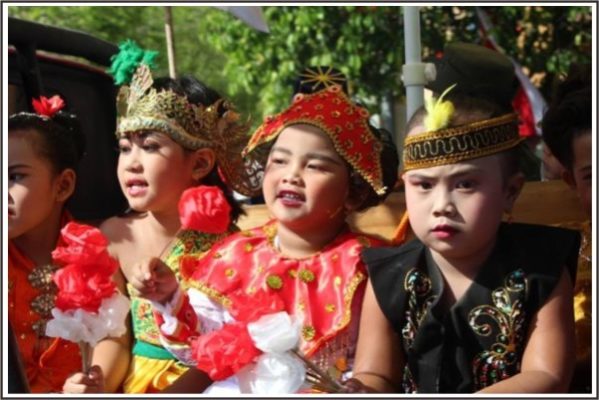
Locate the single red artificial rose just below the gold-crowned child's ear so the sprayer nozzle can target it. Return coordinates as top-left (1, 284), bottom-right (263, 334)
top-left (179, 186), bottom-right (231, 233)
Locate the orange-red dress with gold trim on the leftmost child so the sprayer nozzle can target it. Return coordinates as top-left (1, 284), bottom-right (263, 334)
top-left (8, 214), bottom-right (81, 393)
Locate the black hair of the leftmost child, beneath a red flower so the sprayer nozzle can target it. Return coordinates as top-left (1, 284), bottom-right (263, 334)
top-left (8, 110), bottom-right (85, 174)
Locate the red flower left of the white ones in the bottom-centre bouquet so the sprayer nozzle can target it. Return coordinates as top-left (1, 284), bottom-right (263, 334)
top-left (191, 322), bottom-right (262, 381)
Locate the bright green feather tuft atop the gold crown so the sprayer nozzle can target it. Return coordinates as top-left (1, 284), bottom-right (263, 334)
top-left (107, 39), bottom-right (158, 85)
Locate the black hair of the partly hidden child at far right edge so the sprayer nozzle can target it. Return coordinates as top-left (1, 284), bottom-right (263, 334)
top-left (541, 65), bottom-right (592, 170)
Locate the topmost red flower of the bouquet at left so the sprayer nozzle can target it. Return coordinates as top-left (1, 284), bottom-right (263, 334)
top-left (52, 222), bottom-right (118, 273)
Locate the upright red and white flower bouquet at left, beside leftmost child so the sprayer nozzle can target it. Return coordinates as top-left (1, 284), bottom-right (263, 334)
top-left (46, 222), bottom-right (129, 373)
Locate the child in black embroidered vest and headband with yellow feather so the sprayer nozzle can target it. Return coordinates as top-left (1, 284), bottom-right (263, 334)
top-left (346, 88), bottom-right (578, 393)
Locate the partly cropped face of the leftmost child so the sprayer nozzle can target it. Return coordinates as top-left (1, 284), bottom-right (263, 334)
top-left (8, 131), bottom-right (62, 239)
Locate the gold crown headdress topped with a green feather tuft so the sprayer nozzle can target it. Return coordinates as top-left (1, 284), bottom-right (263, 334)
top-left (109, 41), bottom-right (260, 196)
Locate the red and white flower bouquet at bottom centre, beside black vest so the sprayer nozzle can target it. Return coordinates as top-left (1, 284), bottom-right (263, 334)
top-left (191, 290), bottom-right (341, 394)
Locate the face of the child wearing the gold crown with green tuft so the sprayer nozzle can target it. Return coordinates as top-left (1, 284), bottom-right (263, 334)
top-left (117, 132), bottom-right (194, 212)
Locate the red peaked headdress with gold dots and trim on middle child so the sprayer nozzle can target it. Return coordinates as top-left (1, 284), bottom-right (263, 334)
top-left (243, 85), bottom-right (387, 195)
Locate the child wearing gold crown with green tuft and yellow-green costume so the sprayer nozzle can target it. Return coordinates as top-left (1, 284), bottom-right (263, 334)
top-left (65, 42), bottom-right (254, 393)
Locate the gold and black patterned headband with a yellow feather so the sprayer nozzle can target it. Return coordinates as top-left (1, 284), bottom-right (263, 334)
top-left (403, 85), bottom-right (524, 171)
